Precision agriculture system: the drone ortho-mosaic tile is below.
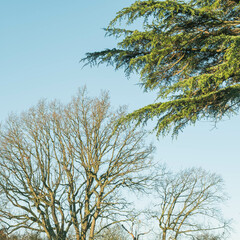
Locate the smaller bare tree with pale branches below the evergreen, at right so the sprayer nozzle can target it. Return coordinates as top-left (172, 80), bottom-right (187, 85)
top-left (149, 168), bottom-right (228, 240)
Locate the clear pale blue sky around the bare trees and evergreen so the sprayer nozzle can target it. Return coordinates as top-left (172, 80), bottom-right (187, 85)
top-left (0, 0), bottom-right (240, 240)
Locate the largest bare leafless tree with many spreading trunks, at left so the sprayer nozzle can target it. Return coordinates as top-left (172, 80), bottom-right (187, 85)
top-left (0, 90), bottom-right (153, 240)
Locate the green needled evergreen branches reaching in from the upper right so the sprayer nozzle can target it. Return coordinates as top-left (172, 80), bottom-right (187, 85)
top-left (82, 0), bottom-right (240, 135)
